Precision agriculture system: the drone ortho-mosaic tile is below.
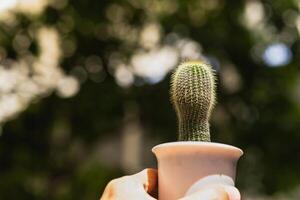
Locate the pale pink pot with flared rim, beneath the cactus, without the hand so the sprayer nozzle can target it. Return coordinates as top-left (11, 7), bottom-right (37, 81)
top-left (152, 142), bottom-right (243, 200)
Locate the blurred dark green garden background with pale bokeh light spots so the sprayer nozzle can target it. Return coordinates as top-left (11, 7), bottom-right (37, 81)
top-left (0, 0), bottom-right (300, 200)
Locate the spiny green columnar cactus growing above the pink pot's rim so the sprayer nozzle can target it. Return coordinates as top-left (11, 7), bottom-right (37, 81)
top-left (171, 61), bottom-right (216, 142)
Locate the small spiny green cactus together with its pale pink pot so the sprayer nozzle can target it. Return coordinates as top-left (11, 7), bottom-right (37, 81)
top-left (152, 61), bottom-right (243, 200)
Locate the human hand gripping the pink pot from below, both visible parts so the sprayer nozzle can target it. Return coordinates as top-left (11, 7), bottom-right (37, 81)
top-left (100, 169), bottom-right (241, 200)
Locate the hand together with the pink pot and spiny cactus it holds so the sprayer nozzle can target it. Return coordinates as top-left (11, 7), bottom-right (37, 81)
top-left (102, 61), bottom-right (243, 200)
